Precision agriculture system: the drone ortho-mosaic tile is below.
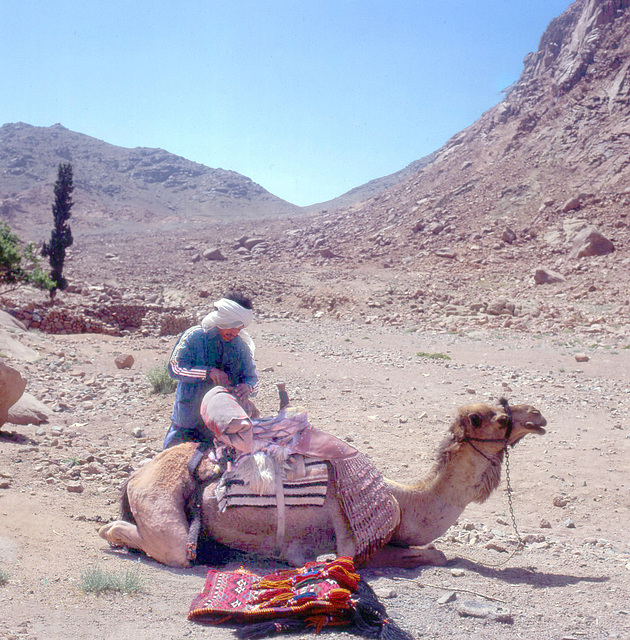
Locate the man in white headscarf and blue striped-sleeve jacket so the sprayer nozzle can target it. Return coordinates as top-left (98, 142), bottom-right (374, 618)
top-left (164, 294), bottom-right (258, 449)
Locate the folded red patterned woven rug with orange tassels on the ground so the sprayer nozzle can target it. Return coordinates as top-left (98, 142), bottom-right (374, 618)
top-left (188, 558), bottom-right (411, 640)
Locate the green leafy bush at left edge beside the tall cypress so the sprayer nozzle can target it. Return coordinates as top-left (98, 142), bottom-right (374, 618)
top-left (0, 222), bottom-right (54, 293)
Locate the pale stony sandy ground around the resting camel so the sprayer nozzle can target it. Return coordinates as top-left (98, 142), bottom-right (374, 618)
top-left (0, 321), bottom-right (630, 640)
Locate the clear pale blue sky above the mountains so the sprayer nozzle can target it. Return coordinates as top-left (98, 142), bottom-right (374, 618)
top-left (0, 0), bottom-right (571, 205)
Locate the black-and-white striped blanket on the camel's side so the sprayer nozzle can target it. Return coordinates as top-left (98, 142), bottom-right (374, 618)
top-left (216, 460), bottom-right (328, 512)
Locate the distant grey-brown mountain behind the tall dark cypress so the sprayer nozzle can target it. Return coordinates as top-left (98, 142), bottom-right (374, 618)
top-left (0, 123), bottom-right (300, 239)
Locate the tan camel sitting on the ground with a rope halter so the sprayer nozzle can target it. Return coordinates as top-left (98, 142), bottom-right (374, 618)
top-left (99, 401), bottom-right (547, 568)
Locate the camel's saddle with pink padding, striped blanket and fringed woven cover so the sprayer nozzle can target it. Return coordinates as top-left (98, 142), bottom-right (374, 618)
top-left (202, 387), bottom-right (400, 560)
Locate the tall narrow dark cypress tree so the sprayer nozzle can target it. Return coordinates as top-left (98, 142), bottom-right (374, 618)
top-left (42, 164), bottom-right (74, 298)
